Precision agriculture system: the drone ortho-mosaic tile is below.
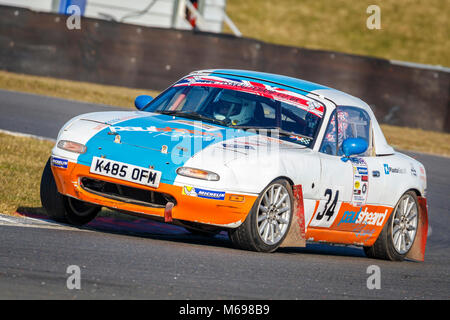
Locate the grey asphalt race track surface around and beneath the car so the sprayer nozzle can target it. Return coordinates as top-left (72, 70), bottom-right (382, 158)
top-left (0, 90), bottom-right (450, 300)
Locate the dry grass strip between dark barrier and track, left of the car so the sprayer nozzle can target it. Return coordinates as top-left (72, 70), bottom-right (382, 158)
top-left (0, 70), bottom-right (158, 108)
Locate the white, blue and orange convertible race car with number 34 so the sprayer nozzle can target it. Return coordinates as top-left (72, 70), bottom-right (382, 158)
top-left (40, 69), bottom-right (428, 261)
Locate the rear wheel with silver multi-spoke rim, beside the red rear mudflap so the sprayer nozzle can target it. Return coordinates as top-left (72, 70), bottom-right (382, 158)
top-left (364, 191), bottom-right (419, 261)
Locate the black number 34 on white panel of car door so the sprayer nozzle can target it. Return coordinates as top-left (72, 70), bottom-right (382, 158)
top-left (309, 188), bottom-right (340, 228)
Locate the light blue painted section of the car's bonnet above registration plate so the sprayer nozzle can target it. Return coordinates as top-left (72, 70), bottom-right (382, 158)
top-left (78, 113), bottom-right (255, 184)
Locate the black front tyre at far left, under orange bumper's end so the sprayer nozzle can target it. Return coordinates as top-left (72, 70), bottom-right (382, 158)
top-left (40, 159), bottom-right (101, 226)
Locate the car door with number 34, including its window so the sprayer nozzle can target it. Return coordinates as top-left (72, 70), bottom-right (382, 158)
top-left (309, 106), bottom-right (383, 231)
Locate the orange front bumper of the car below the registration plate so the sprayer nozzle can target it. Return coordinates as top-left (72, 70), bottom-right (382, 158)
top-left (52, 162), bottom-right (257, 227)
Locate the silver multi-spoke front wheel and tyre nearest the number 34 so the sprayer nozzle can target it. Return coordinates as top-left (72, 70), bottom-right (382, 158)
top-left (228, 179), bottom-right (294, 252)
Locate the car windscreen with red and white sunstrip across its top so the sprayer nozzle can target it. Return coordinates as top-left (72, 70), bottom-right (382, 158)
top-left (143, 77), bottom-right (325, 146)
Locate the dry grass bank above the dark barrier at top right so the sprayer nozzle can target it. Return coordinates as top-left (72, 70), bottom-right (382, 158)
top-left (227, 0), bottom-right (450, 66)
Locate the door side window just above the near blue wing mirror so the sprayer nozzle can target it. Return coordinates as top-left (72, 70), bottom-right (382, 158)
top-left (337, 106), bottom-right (372, 156)
